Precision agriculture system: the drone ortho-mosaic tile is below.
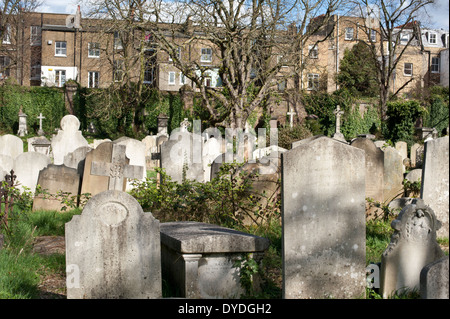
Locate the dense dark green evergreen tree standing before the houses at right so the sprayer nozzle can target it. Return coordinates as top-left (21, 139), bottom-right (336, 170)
top-left (337, 42), bottom-right (379, 97)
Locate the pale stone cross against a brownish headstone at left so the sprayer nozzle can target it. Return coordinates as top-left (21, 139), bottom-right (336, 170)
top-left (91, 145), bottom-right (144, 191)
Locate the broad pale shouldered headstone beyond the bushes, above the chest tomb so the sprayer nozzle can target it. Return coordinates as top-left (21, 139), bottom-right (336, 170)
top-left (160, 131), bottom-right (204, 183)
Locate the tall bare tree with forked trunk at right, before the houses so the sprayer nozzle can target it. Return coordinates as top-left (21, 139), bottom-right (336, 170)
top-left (351, 0), bottom-right (434, 119)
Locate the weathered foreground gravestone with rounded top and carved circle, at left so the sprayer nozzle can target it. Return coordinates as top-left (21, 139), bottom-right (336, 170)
top-left (65, 191), bottom-right (162, 299)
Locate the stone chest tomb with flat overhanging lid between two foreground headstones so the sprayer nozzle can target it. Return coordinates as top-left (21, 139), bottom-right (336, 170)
top-left (161, 222), bottom-right (269, 299)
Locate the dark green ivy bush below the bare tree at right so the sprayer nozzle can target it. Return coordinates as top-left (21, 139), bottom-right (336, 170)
top-left (383, 100), bottom-right (425, 146)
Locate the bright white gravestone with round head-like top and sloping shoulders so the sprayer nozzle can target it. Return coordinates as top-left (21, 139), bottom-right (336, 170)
top-left (52, 115), bottom-right (88, 165)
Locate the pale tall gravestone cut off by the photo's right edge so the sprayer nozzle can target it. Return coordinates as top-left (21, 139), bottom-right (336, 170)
top-left (420, 136), bottom-right (449, 238)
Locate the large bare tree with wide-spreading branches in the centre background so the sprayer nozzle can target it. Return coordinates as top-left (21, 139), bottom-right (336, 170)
top-left (148, 0), bottom-right (340, 128)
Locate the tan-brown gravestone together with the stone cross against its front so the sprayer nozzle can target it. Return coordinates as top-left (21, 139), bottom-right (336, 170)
top-left (81, 142), bottom-right (144, 195)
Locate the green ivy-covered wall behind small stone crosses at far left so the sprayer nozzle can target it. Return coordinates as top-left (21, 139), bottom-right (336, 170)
top-left (0, 83), bottom-right (67, 135)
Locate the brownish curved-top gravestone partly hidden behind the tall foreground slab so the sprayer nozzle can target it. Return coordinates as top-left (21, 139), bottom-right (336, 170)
top-left (351, 137), bottom-right (384, 216)
